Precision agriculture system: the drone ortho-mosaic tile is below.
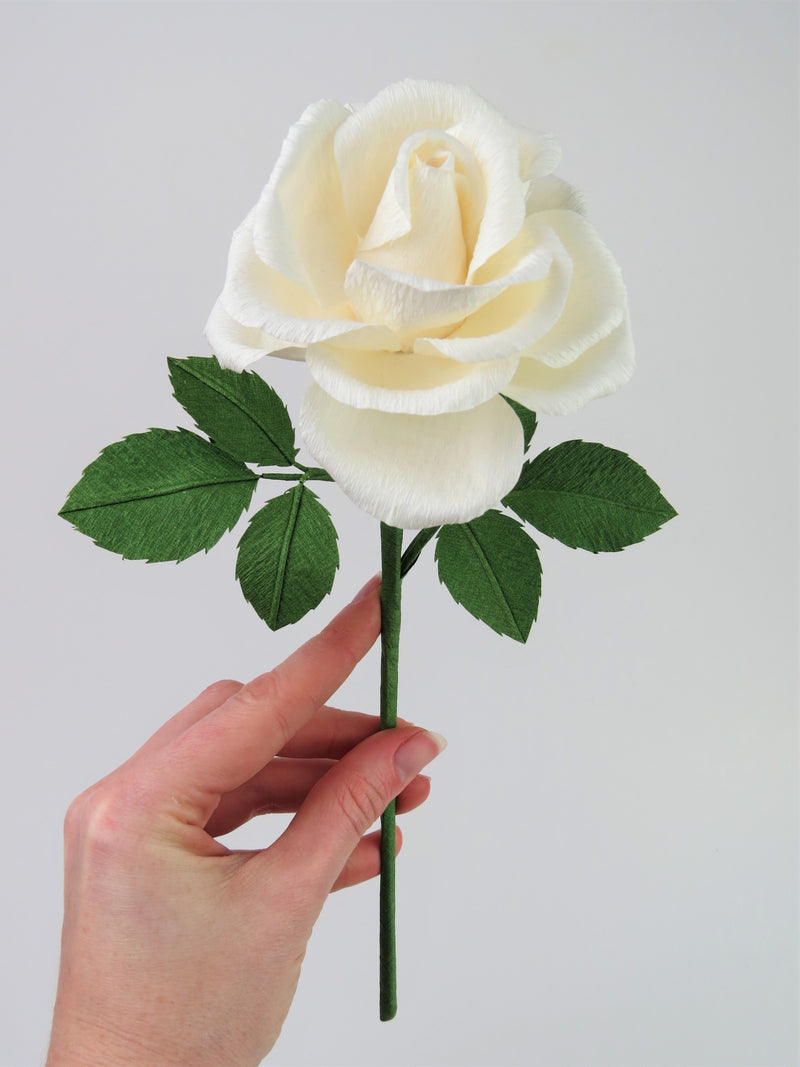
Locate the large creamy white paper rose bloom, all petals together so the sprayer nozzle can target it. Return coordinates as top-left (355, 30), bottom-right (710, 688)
top-left (206, 81), bottom-right (634, 529)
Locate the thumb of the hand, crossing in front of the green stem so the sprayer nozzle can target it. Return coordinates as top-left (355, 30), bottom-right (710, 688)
top-left (273, 727), bottom-right (447, 897)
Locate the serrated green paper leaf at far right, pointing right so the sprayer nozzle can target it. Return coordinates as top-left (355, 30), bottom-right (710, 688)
top-left (502, 441), bottom-right (677, 552)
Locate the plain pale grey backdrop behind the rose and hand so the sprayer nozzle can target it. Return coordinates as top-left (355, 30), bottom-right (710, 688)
top-left (0, 2), bottom-right (798, 1067)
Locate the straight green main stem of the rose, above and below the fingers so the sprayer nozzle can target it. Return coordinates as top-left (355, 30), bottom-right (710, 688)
top-left (380, 523), bottom-right (403, 1022)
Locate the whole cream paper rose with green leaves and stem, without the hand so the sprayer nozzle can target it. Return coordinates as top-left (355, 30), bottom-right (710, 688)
top-left (61, 81), bottom-right (675, 1019)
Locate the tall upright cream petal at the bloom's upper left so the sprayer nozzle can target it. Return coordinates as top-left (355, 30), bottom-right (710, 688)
top-left (254, 100), bottom-right (357, 306)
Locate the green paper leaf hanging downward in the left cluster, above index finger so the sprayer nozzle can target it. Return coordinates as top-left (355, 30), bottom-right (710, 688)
top-left (236, 484), bottom-right (339, 630)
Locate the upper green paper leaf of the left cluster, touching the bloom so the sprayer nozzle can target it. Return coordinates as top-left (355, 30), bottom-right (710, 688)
top-left (166, 355), bottom-right (298, 466)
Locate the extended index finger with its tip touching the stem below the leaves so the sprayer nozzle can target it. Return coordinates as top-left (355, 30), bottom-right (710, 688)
top-left (154, 577), bottom-right (381, 825)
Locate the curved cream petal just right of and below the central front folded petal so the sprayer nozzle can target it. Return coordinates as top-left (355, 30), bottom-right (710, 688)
top-left (414, 216), bottom-right (572, 363)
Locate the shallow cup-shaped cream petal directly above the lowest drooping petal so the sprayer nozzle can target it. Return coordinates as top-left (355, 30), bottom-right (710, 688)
top-left (306, 345), bottom-right (518, 415)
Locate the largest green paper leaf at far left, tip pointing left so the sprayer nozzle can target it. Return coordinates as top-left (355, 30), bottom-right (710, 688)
top-left (59, 430), bottom-right (258, 562)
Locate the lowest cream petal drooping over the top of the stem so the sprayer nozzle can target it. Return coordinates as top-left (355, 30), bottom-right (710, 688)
top-left (300, 385), bottom-right (524, 529)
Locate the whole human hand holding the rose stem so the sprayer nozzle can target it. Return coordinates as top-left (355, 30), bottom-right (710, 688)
top-left (48, 579), bottom-right (444, 1067)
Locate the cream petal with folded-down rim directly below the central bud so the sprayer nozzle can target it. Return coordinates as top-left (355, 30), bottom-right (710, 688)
top-left (345, 248), bottom-right (553, 341)
